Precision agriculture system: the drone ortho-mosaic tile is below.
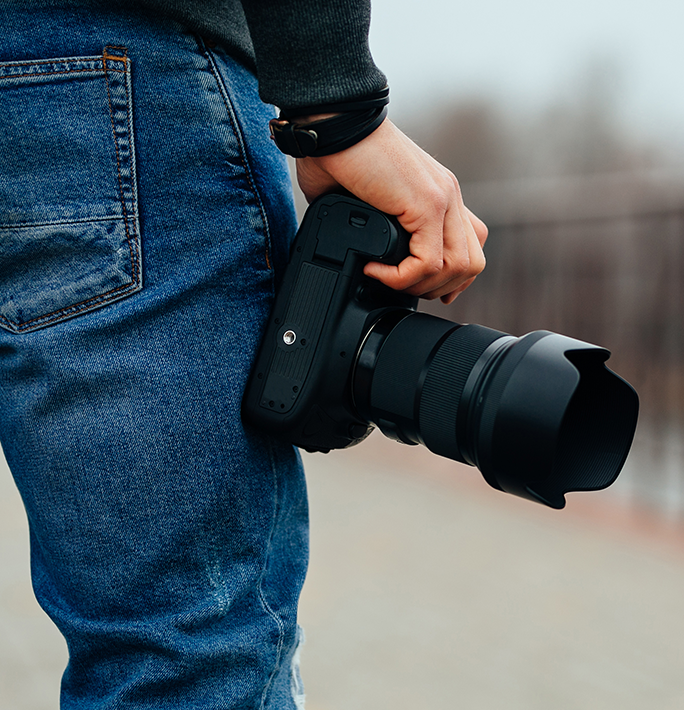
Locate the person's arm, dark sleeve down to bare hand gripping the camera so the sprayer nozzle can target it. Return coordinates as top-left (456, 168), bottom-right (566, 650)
top-left (243, 0), bottom-right (487, 303)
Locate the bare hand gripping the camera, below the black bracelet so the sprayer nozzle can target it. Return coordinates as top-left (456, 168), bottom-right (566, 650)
top-left (297, 119), bottom-right (487, 303)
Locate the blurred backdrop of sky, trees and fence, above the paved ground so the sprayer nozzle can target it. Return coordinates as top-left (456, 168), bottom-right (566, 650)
top-left (372, 0), bottom-right (684, 518)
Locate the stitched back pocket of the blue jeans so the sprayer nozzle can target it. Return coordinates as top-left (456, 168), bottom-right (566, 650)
top-left (0, 47), bottom-right (142, 333)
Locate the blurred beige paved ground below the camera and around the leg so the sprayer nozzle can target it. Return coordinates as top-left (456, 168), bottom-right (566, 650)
top-left (0, 435), bottom-right (684, 710)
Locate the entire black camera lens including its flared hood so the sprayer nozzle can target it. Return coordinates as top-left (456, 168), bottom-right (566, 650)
top-left (352, 309), bottom-right (638, 508)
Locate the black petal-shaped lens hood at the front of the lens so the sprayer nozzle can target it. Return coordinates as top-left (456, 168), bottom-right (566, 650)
top-left (464, 331), bottom-right (639, 508)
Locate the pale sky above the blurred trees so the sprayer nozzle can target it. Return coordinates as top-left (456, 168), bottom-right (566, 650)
top-left (371, 0), bottom-right (684, 152)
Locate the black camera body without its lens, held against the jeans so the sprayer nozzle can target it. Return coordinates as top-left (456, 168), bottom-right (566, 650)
top-left (243, 194), bottom-right (418, 452)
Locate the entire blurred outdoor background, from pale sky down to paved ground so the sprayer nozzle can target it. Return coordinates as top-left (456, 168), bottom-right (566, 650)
top-left (0, 0), bottom-right (684, 710)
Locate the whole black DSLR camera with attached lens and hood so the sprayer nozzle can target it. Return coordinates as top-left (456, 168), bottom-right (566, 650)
top-left (243, 194), bottom-right (638, 508)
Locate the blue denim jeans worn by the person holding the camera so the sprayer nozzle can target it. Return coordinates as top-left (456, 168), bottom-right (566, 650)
top-left (0, 0), bottom-right (308, 710)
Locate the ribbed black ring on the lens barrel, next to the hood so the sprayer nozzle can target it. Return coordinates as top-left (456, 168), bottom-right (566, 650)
top-left (419, 325), bottom-right (506, 461)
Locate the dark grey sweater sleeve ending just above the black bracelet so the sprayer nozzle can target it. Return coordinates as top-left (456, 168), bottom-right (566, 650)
top-left (242, 0), bottom-right (387, 108)
